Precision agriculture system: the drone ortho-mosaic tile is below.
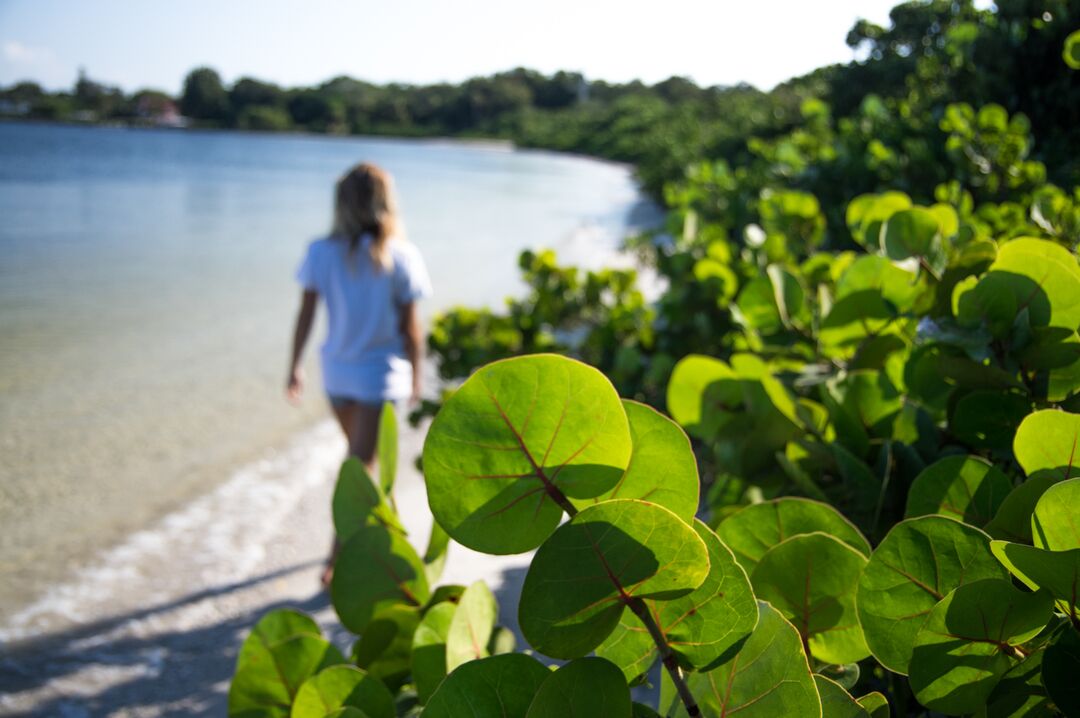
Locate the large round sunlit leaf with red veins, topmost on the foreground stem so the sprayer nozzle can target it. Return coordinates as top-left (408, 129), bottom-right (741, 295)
top-left (423, 354), bottom-right (632, 554)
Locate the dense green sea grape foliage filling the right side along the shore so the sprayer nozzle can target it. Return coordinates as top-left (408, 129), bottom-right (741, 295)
top-left (225, 0), bottom-right (1080, 718)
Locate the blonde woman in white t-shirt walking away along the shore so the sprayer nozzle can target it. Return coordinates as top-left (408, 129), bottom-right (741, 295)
top-left (286, 164), bottom-right (431, 581)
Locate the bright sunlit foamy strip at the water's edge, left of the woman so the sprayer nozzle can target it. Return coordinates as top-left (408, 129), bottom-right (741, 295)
top-left (0, 421), bottom-right (345, 644)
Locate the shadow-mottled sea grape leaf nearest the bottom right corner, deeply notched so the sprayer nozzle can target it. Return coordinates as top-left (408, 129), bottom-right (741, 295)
top-left (909, 579), bottom-right (1053, 715)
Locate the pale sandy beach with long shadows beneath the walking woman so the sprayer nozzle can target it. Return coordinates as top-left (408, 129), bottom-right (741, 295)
top-left (0, 412), bottom-right (530, 718)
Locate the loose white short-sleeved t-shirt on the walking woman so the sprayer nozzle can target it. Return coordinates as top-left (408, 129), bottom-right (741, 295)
top-left (296, 235), bottom-right (431, 403)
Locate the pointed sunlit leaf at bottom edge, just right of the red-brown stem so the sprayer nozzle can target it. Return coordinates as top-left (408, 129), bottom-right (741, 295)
top-left (661, 601), bottom-right (822, 718)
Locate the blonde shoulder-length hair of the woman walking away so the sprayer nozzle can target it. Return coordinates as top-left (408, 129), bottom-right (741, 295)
top-left (330, 162), bottom-right (401, 271)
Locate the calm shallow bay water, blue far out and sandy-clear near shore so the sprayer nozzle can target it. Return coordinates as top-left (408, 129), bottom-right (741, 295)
top-left (0, 124), bottom-right (651, 617)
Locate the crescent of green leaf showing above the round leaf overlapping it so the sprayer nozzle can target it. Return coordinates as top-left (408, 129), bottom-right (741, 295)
top-left (716, 497), bottom-right (870, 572)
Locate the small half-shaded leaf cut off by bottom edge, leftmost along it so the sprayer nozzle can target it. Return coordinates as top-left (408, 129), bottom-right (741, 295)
top-left (292, 665), bottom-right (397, 718)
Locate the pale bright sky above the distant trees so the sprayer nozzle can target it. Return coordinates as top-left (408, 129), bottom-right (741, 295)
top-left (0, 0), bottom-right (984, 93)
